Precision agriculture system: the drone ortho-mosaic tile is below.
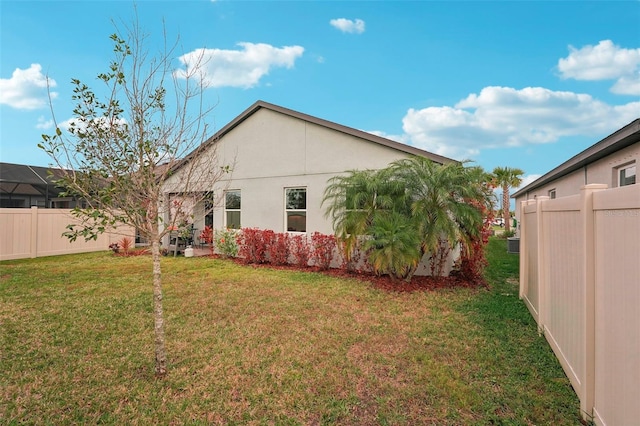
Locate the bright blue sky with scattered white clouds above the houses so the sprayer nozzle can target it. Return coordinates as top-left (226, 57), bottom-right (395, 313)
top-left (0, 0), bottom-right (640, 188)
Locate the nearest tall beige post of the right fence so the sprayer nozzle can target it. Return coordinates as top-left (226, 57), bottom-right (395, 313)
top-left (580, 183), bottom-right (608, 420)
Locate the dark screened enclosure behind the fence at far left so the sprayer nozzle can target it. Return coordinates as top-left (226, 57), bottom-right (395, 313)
top-left (0, 163), bottom-right (81, 209)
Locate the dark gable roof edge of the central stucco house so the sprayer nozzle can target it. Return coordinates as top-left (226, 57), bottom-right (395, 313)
top-left (176, 100), bottom-right (457, 168)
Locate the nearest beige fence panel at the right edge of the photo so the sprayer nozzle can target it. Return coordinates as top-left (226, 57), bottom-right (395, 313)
top-left (593, 185), bottom-right (640, 425)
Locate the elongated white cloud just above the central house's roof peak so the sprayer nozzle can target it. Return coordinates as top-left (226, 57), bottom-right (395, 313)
top-left (176, 43), bottom-right (304, 89)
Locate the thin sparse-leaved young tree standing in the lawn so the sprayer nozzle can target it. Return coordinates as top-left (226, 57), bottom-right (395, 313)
top-left (39, 21), bottom-right (230, 376)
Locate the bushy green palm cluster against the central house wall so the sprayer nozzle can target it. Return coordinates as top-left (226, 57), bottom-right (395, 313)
top-left (322, 157), bottom-right (490, 280)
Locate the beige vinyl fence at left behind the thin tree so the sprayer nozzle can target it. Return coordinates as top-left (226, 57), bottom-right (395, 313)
top-left (0, 207), bottom-right (135, 260)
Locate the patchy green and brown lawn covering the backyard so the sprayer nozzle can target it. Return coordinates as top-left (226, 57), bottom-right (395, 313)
top-left (0, 239), bottom-right (580, 425)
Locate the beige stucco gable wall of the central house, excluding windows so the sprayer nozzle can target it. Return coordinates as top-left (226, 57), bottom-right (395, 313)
top-left (166, 108), bottom-right (416, 234)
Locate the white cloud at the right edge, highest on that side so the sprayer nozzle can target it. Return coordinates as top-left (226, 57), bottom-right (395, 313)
top-left (558, 40), bottom-right (640, 95)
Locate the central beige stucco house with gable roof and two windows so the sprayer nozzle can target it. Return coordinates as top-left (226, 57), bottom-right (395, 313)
top-left (168, 101), bottom-right (454, 240)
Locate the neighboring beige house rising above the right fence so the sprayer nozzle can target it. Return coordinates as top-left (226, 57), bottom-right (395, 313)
top-left (511, 118), bottom-right (640, 208)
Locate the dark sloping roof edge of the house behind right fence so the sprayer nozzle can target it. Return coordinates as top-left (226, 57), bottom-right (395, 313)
top-left (511, 118), bottom-right (640, 198)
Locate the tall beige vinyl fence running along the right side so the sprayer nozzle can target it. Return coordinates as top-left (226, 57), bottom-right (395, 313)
top-left (520, 184), bottom-right (640, 425)
